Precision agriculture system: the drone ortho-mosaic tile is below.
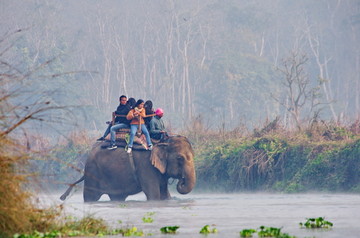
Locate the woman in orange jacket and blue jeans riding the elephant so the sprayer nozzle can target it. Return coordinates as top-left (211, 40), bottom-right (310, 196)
top-left (126, 99), bottom-right (153, 153)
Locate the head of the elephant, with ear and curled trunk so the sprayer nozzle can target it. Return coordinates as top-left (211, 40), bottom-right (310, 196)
top-left (151, 136), bottom-right (196, 194)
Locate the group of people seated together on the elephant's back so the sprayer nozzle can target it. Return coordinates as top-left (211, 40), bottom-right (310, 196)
top-left (98, 95), bottom-right (167, 153)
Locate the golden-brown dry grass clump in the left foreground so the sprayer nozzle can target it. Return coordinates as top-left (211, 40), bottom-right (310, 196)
top-left (0, 138), bottom-right (59, 237)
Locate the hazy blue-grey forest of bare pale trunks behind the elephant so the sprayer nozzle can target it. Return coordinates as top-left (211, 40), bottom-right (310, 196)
top-left (0, 0), bottom-right (360, 133)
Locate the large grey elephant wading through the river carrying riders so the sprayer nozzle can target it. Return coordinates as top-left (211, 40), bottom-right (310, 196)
top-left (60, 136), bottom-right (196, 202)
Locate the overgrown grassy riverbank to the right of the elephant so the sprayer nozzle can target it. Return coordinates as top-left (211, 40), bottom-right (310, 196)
top-left (189, 120), bottom-right (360, 193)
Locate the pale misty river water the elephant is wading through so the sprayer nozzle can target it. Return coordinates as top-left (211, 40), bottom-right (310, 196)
top-left (41, 191), bottom-right (360, 238)
